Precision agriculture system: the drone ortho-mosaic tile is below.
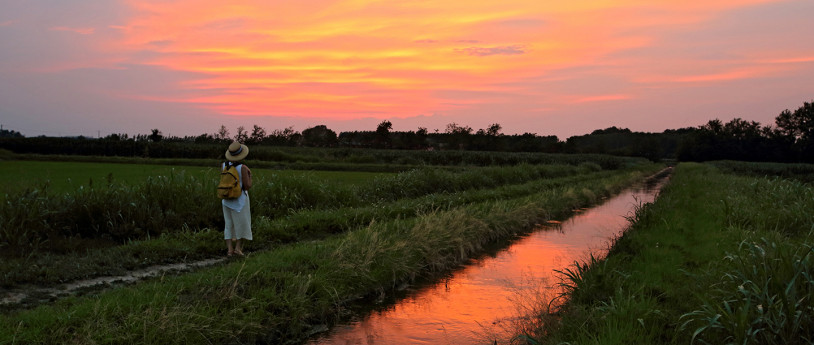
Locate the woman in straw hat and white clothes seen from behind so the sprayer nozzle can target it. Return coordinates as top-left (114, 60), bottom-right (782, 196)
top-left (221, 142), bottom-right (252, 256)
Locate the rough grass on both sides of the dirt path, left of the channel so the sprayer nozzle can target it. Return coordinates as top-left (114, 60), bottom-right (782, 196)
top-left (0, 152), bottom-right (661, 344)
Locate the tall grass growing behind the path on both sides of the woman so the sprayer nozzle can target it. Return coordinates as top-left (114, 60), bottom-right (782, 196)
top-left (0, 165), bottom-right (593, 256)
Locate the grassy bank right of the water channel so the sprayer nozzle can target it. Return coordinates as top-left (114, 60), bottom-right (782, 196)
top-left (535, 163), bottom-right (814, 344)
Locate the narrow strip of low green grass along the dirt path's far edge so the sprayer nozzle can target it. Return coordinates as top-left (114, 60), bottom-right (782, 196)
top-left (0, 166), bottom-right (657, 286)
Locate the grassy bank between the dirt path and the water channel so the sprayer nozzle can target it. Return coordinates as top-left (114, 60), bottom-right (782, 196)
top-left (0, 165), bottom-right (658, 344)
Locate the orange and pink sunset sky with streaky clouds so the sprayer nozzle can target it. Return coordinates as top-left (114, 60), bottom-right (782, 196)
top-left (0, 0), bottom-right (814, 140)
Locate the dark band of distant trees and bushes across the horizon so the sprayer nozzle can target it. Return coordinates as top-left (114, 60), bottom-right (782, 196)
top-left (0, 102), bottom-right (814, 165)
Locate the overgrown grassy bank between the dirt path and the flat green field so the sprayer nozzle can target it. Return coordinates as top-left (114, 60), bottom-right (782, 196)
top-left (0, 157), bottom-right (644, 286)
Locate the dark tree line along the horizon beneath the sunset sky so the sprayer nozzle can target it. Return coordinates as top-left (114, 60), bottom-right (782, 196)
top-left (0, 101), bottom-right (814, 162)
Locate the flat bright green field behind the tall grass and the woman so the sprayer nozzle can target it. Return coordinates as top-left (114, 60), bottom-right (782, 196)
top-left (0, 161), bottom-right (393, 195)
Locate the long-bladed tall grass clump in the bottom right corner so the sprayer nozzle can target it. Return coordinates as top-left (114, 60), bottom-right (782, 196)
top-left (682, 233), bottom-right (814, 344)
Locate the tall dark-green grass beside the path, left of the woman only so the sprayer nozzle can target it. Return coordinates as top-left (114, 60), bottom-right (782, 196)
top-left (0, 171), bottom-right (217, 255)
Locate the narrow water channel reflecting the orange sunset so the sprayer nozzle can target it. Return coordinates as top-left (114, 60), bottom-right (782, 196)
top-left (311, 173), bottom-right (663, 345)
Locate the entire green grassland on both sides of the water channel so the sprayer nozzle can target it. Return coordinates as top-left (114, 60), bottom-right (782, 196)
top-left (0, 157), bottom-right (814, 344)
